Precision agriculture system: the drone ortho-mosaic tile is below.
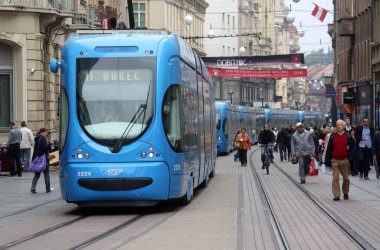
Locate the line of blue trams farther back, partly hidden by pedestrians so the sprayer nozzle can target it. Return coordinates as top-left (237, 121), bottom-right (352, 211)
top-left (215, 101), bottom-right (325, 155)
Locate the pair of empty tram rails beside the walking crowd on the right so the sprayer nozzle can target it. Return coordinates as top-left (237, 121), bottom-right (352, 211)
top-left (250, 149), bottom-right (376, 249)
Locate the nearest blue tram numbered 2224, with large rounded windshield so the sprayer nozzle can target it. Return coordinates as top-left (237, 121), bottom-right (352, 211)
top-left (50, 31), bottom-right (216, 206)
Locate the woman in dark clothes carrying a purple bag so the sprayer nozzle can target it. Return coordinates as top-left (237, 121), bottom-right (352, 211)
top-left (30, 128), bottom-right (51, 193)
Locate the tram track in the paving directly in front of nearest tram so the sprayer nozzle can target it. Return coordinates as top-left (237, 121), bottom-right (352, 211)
top-left (0, 200), bottom-right (186, 250)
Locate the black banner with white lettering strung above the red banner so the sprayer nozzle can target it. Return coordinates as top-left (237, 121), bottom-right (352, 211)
top-left (202, 53), bottom-right (305, 68)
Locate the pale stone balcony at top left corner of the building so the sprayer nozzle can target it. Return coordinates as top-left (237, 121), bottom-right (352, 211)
top-left (0, 0), bottom-right (75, 13)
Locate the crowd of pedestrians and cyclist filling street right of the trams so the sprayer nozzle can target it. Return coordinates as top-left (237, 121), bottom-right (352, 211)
top-left (230, 117), bottom-right (380, 201)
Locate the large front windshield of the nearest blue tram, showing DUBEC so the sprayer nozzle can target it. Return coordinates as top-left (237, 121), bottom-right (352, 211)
top-left (76, 58), bottom-right (155, 146)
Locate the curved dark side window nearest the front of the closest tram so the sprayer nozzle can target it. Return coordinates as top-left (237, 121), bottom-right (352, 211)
top-left (162, 85), bottom-right (182, 152)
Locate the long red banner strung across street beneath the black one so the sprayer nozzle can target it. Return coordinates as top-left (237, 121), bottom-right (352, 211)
top-left (208, 68), bottom-right (307, 78)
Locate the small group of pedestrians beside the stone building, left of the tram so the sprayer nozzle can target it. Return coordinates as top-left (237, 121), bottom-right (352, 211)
top-left (0, 121), bottom-right (52, 193)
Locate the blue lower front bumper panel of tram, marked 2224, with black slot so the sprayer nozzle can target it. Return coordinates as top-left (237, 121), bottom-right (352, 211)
top-left (60, 162), bottom-right (170, 203)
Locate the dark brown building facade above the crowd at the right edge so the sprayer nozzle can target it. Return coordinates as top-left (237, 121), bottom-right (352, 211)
top-left (330, 0), bottom-right (376, 124)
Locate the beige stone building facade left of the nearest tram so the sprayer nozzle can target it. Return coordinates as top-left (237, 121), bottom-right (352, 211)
top-left (0, 0), bottom-right (126, 143)
